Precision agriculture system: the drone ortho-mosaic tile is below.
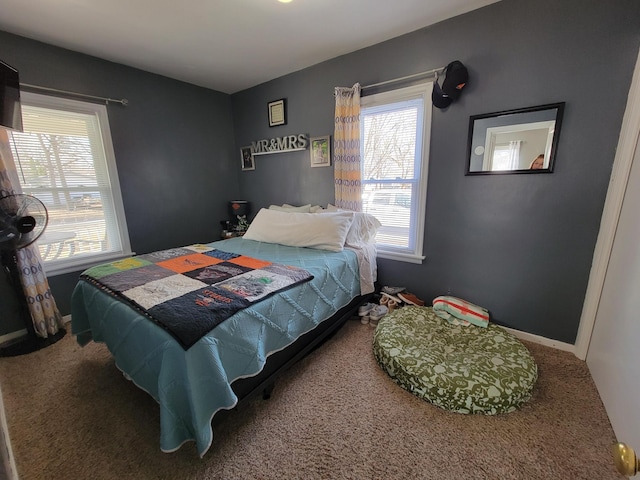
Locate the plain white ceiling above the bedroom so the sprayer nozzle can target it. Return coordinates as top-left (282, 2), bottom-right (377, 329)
top-left (0, 0), bottom-right (498, 93)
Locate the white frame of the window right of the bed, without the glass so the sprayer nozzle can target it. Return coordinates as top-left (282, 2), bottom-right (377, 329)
top-left (360, 81), bottom-right (433, 264)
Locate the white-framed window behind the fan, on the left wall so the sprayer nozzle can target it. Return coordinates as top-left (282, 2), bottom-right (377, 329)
top-left (10, 92), bottom-right (131, 274)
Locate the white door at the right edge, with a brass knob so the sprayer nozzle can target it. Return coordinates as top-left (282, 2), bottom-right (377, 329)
top-left (587, 94), bottom-right (640, 455)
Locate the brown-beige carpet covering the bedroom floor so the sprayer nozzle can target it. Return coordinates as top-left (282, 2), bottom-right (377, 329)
top-left (0, 320), bottom-right (623, 480)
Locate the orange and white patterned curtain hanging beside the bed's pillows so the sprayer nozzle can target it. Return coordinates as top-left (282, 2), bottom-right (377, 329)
top-left (333, 83), bottom-right (362, 212)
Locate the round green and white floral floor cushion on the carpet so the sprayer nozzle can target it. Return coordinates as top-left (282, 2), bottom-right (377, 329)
top-left (373, 307), bottom-right (538, 415)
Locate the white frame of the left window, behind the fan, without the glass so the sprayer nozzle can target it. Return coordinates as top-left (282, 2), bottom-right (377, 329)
top-left (12, 92), bottom-right (133, 276)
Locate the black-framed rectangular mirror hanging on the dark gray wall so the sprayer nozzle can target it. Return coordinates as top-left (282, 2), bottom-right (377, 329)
top-left (466, 102), bottom-right (565, 175)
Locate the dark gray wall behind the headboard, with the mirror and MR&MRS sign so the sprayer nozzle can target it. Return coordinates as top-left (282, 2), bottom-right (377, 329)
top-left (232, 0), bottom-right (640, 343)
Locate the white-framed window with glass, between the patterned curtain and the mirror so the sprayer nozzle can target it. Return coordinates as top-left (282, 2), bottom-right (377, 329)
top-left (360, 83), bottom-right (433, 263)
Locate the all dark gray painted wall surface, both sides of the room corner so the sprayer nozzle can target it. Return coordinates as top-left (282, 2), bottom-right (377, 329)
top-left (0, 0), bottom-right (640, 343)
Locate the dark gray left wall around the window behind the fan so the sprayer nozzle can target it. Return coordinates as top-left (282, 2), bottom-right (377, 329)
top-left (0, 31), bottom-right (239, 324)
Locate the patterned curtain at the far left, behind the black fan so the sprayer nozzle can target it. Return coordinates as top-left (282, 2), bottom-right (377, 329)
top-left (0, 128), bottom-right (64, 338)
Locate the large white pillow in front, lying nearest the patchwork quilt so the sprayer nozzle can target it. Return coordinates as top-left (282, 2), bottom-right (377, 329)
top-left (243, 208), bottom-right (353, 252)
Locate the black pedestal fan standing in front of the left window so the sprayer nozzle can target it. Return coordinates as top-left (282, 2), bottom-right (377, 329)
top-left (0, 194), bottom-right (66, 357)
